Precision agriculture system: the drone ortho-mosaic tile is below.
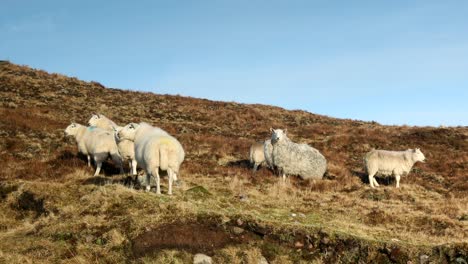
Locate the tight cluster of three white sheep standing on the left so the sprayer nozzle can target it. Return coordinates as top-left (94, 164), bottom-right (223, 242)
top-left (65, 114), bottom-right (185, 195)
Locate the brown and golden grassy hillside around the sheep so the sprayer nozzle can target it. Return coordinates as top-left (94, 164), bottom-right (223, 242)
top-left (0, 62), bottom-right (468, 263)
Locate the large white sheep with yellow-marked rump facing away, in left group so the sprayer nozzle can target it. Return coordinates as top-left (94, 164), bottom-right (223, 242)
top-left (118, 122), bottom-right (185, 195)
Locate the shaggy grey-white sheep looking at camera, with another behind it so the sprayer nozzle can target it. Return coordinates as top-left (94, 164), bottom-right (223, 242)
top-left (270, 128), bottom-right (327, 181)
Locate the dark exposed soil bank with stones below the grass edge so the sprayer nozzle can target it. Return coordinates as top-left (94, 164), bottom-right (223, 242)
top-left (132, 219), bottom-right (468, 263)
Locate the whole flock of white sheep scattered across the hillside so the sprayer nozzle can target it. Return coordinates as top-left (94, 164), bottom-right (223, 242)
top-left (65, 114), bottom-right (425, 195)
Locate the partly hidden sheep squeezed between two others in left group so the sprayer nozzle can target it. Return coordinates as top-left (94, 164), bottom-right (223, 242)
top-left (88, 114), bottom-right (137, 175)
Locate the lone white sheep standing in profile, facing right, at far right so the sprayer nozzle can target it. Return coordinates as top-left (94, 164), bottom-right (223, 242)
top-left (364, 148), bottom-right (426, 188)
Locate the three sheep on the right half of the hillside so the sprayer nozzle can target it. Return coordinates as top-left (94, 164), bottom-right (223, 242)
top-left (249, 128), bottom-right (426, 188)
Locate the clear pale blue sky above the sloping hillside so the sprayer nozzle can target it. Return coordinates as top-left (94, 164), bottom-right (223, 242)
top-left (0, 0), bottom-right (468, 126)
